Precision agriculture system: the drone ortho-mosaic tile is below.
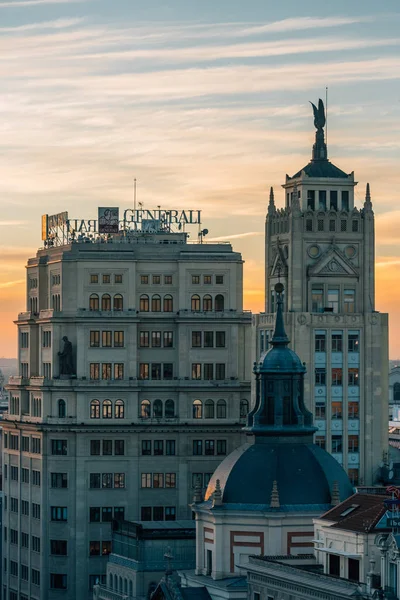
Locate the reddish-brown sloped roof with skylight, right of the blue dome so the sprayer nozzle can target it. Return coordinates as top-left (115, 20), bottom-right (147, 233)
top-left (320, 494), bottom-right (390, 533)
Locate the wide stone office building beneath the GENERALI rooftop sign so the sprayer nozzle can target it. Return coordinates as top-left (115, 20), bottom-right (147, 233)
top-left (3, 212), bottom-right (251, 600)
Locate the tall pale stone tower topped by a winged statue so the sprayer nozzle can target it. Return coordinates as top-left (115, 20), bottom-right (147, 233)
top-left (255, 100), bottom-right (388, 485)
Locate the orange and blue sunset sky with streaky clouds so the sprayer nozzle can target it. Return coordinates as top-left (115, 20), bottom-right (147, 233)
top-left (0, 0), bottom-right (400, 358)
